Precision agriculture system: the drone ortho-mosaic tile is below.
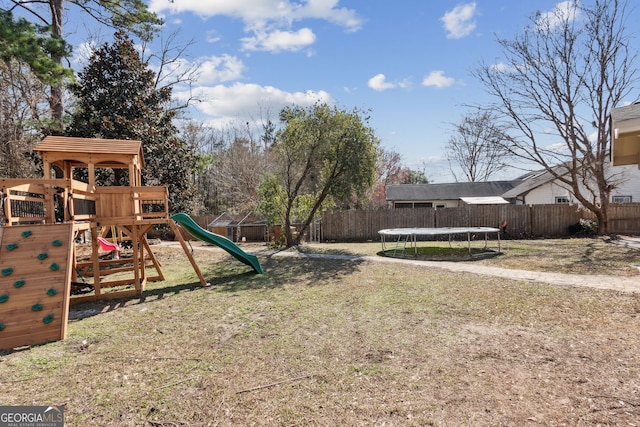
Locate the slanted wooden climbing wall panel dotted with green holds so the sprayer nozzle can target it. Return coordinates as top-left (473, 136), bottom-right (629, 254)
top-left (0, 224), bottom-right (73, 350)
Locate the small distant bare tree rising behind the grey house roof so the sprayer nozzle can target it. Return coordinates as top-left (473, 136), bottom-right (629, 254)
top-left (446, 109), bottom-right (511, 182)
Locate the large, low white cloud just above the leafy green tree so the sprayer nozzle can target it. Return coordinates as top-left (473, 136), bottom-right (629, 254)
top-left (173, 83), bottom-right (333, 125)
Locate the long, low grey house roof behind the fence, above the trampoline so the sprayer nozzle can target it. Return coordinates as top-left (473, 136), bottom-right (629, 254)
top-left (387, 180), bottom-right (520, 201)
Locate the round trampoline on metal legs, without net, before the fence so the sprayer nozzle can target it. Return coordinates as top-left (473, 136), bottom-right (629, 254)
top-left (378, 227), bottom-right (500, 257)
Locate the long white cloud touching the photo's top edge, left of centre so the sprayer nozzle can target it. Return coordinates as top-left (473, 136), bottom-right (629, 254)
top-left (149, 0), bottom-right (362, 31)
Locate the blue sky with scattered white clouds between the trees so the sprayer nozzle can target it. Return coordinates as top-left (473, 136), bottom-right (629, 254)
top-left (67, 0), bottom-right (636, 182)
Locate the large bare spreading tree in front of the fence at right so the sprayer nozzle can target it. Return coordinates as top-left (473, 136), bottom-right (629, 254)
top-left (475, 0), bottom-right (637, 233)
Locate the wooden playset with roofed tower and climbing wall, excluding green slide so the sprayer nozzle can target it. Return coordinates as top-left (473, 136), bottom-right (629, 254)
top-left (0, 136), bottom-right (212, 349)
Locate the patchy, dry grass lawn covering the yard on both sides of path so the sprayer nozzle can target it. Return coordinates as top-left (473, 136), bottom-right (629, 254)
top-left (0, 239), bottom-right (640, 426)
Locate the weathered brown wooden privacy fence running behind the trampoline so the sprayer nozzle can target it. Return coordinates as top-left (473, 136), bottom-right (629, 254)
top-left (320, 203), bottom-right (640, 242)
